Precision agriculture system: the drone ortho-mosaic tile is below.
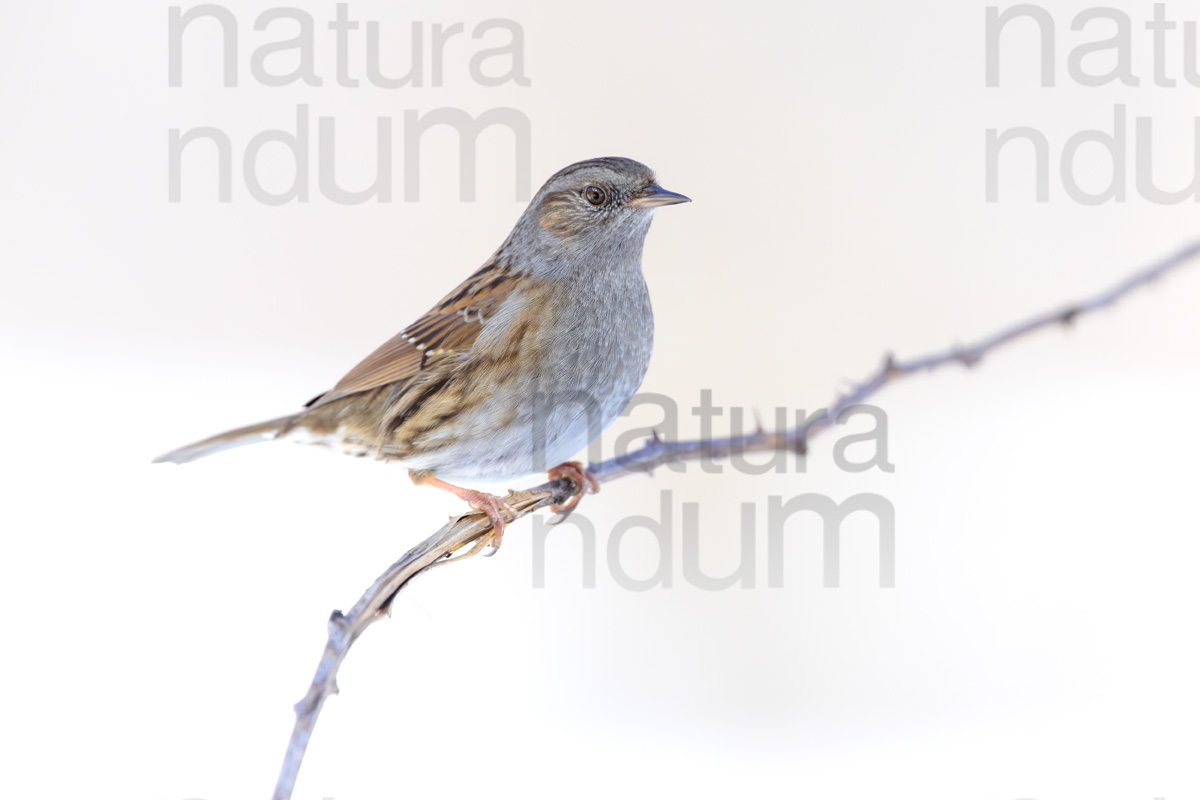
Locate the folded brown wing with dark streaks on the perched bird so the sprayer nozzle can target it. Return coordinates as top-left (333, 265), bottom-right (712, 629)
top-left (307, 258), bottom-right (520, 408)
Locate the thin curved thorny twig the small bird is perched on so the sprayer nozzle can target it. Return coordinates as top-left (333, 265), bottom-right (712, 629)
top-left (274, 240), bottom-right (1200, 800)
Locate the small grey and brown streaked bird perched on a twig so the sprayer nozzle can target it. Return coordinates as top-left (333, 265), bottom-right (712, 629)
top-left (154, 157), bottom-right (690, 552)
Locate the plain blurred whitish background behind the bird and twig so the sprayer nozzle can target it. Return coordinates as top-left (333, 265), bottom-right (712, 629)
top-left (0, 0), bottom-right (1200, 800)
